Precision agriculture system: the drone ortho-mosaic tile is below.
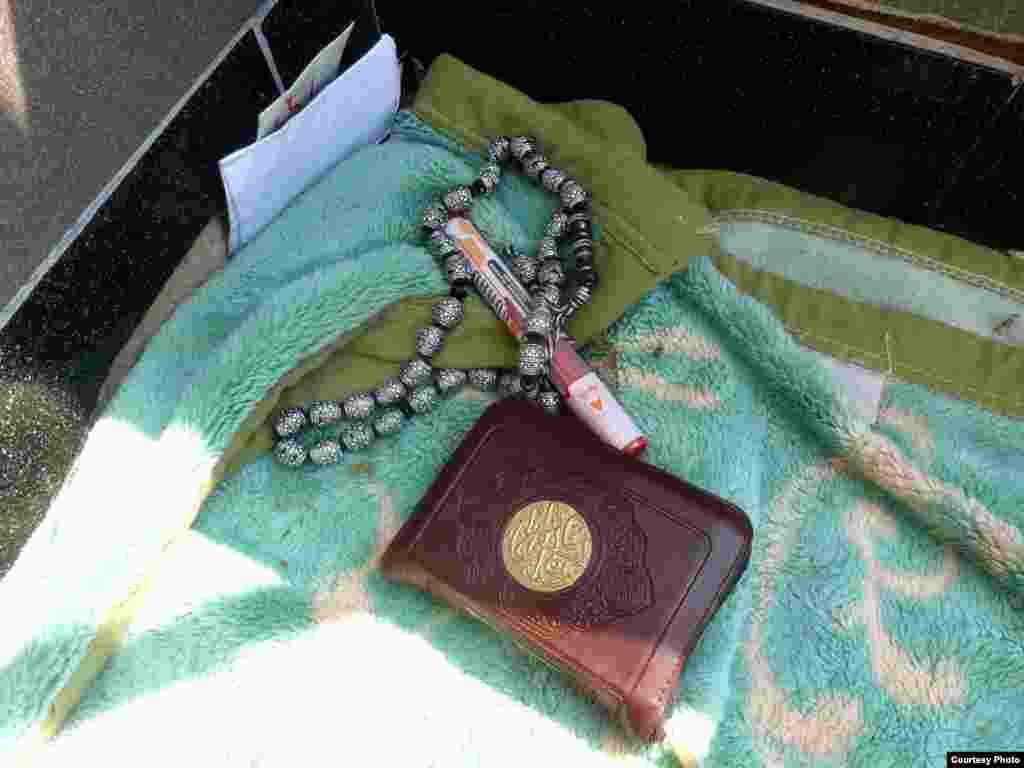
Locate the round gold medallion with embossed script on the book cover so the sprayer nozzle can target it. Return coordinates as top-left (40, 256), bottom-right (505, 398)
top-left (502, 501), bottom-right (594, 592)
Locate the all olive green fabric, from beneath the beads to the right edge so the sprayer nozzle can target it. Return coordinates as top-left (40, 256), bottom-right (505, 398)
top-left (224, 55), bottom-right (1024, 481)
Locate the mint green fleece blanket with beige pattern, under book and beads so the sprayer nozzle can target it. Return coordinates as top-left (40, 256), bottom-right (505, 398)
top-left (6, 114), bottom-right (1024, 768)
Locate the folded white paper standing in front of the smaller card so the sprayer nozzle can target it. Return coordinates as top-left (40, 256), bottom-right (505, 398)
top-left (220, 35), bottom-right (401, 253)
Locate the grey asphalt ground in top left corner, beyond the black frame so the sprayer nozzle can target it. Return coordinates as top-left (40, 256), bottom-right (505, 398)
top-left (0, 0), bottom-right (262, 319)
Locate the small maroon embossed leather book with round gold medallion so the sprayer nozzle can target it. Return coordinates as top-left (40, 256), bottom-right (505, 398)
top-left (382, 399), bottom-right (753, 740)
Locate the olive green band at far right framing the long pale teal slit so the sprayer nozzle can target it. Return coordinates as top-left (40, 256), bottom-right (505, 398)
top-left (670, 171), bottom-right (1024, 418)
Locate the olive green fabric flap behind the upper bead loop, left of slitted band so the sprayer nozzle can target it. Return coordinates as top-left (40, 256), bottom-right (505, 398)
top-left (415, 55), bottom-right (714, 341)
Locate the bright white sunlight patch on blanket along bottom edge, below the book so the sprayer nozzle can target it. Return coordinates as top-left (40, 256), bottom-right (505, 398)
top-left (40, 614), bottom-right (622, 768)
